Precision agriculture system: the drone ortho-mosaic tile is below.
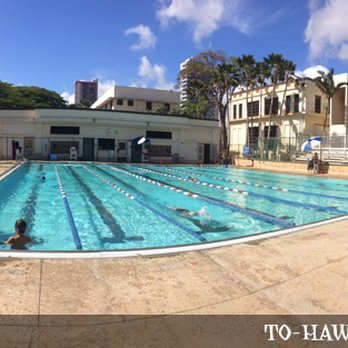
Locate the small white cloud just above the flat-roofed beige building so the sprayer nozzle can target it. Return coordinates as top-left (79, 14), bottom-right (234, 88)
top-left (138, 56), bottom-right (174, 89)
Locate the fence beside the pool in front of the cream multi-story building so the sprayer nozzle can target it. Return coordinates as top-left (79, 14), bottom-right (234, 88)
top-left (231, 134), bottom-right (348, 162)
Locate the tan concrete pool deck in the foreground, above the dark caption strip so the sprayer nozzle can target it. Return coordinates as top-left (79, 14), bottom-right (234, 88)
top-left (0, 163), bottom-right (348, 346)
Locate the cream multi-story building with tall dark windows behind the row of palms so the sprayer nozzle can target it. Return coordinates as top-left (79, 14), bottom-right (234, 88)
top-left (229, 78), bottom-right (329, 158)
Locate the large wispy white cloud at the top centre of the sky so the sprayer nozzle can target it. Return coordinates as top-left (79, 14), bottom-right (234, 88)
top-left (157, 0), bottom-right (250, 44)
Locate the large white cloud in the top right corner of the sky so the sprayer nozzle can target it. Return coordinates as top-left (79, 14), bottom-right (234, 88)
top-left (305, 0), bottom-right (348, 61)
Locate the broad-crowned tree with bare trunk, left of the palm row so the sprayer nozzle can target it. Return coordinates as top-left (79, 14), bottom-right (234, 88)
top-left (179, 51), bottom-right (240, 158)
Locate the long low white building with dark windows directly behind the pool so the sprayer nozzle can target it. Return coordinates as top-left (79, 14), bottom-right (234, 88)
top-left (0, 109), bottom-right (219, 163)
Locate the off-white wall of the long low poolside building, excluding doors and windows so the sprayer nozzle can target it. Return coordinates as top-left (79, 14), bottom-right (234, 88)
top-left (0, 109), bottom-right (219, 162)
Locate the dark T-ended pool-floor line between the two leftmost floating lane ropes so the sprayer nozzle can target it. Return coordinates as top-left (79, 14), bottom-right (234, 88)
top-left (67, 167), bottom-right (144, 243)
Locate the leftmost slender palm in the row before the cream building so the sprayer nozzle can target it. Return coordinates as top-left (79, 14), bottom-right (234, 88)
top-left (236, 54), bottom-right (256, 147)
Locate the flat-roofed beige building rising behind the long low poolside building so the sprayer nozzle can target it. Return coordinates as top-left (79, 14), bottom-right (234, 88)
top-left (91, 86), bottom-right (180, 113)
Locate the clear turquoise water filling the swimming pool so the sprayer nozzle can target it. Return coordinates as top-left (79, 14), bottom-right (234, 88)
top-left (0, 163), bottom-right (348, 251)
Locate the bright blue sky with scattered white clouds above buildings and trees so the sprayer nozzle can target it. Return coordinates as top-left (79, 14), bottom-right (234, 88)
top-left (0, 0), bottom-right (348, 99)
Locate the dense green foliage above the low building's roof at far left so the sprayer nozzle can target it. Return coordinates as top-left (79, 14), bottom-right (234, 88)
top-left (0, 81), bottom-right (67, 109)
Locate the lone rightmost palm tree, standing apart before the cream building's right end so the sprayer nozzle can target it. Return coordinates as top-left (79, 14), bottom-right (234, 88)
top-left (314, 68), bottom-right (347, 134)
